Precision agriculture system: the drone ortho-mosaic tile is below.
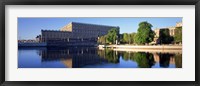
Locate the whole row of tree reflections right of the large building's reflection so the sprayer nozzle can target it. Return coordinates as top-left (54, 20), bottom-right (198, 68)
top-left (98, 49), bottom-right (182, 68)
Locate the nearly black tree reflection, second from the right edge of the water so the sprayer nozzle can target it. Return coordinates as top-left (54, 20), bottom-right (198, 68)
top-left (158, 53), bottom-right (173, 68)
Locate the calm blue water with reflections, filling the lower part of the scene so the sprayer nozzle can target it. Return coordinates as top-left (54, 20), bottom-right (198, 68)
top-left (18, 47), bottom-right (182, 68)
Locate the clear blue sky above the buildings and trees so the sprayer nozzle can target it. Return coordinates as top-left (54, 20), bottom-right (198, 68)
top-left (18, 17), bottom-right (182, 39)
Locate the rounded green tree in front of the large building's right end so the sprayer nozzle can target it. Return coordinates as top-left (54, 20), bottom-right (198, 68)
top-left (106, 28), bottom-right (119, 44)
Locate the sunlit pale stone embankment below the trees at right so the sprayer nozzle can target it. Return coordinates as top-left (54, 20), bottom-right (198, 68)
top-left (98, 45), bottom-right (182, 53)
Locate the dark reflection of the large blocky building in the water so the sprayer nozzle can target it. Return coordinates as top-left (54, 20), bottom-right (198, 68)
top-left (41, 48), bottom-right (107, 68)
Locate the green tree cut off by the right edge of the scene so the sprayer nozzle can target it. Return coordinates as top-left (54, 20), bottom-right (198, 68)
top-left (174, 27), bottom-right (182, 42)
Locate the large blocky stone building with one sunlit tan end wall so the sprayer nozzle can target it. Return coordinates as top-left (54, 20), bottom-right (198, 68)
top-left (40, 22), bottom-right (119, 44)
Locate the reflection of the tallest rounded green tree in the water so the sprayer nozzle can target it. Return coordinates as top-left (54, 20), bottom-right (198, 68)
top-left (134, 52), bottom-right (155, 68)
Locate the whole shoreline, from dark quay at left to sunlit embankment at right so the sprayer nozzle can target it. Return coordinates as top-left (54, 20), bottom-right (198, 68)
top-left (18, 43), bottom-right (182, 50)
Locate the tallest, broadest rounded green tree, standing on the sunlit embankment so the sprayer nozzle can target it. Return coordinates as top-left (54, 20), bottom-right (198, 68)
top-left (134, 21), bottom-right (155, 44)
